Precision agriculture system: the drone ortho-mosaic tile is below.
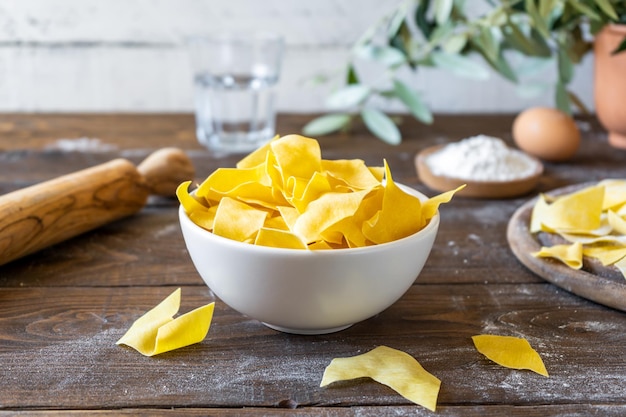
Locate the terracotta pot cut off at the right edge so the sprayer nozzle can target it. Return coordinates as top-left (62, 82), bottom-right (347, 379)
top-left (594, 25), bottom-right (626, 149)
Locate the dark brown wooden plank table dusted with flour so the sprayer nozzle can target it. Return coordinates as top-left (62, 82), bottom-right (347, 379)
top-left (0, 114), bottom-right (626, 416)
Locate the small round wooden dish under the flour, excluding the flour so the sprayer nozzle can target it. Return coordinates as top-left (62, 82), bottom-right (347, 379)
top-left (415, 145), bottom-right (543, 198)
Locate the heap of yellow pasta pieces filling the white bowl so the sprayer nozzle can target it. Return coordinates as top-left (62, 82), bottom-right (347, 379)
top-left (177, 135), bottom-right (462, 249)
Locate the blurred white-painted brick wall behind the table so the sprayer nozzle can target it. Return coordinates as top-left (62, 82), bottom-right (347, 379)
top-left (0, 0), bottom-right (593, 112)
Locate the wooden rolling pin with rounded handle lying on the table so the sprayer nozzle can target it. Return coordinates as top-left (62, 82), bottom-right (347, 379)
top-left (0, 148), bottom-right (195, 265)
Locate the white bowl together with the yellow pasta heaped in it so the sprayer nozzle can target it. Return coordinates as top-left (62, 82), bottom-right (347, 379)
top-left (177, 135), bottom-right (454, 334)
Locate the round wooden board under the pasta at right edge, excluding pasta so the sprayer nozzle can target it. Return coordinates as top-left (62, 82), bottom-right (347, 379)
top-left (507, 184), bottom-right (626, 311)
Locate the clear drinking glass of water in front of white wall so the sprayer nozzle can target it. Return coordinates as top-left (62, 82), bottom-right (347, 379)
top-left (187, 32), bottom-right (284, 153)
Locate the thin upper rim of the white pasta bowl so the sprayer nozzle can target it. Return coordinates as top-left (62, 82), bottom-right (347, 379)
top-left (178, 183), bottom-right (440, 256)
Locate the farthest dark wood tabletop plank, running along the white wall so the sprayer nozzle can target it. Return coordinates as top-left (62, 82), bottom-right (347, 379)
top-left (0, 113), bottom-right (520, 153)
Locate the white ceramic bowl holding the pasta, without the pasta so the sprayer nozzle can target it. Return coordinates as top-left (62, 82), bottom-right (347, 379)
top-left (179, 187), bottom-right (439, 334)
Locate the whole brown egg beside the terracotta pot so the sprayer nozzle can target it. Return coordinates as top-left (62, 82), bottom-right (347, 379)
top-left (513, 107), bottom-right (580, 161)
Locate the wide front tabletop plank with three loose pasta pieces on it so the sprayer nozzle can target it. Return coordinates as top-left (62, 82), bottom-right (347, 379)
top-left (0, 284), bottom-right (626, 409)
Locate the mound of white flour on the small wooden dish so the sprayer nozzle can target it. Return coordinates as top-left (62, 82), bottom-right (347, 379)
top-left (426, 135), bottom-right (537, 181)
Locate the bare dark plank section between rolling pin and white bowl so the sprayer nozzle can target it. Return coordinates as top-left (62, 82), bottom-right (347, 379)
top-left (0, 206), bottom-right (202, 287)
